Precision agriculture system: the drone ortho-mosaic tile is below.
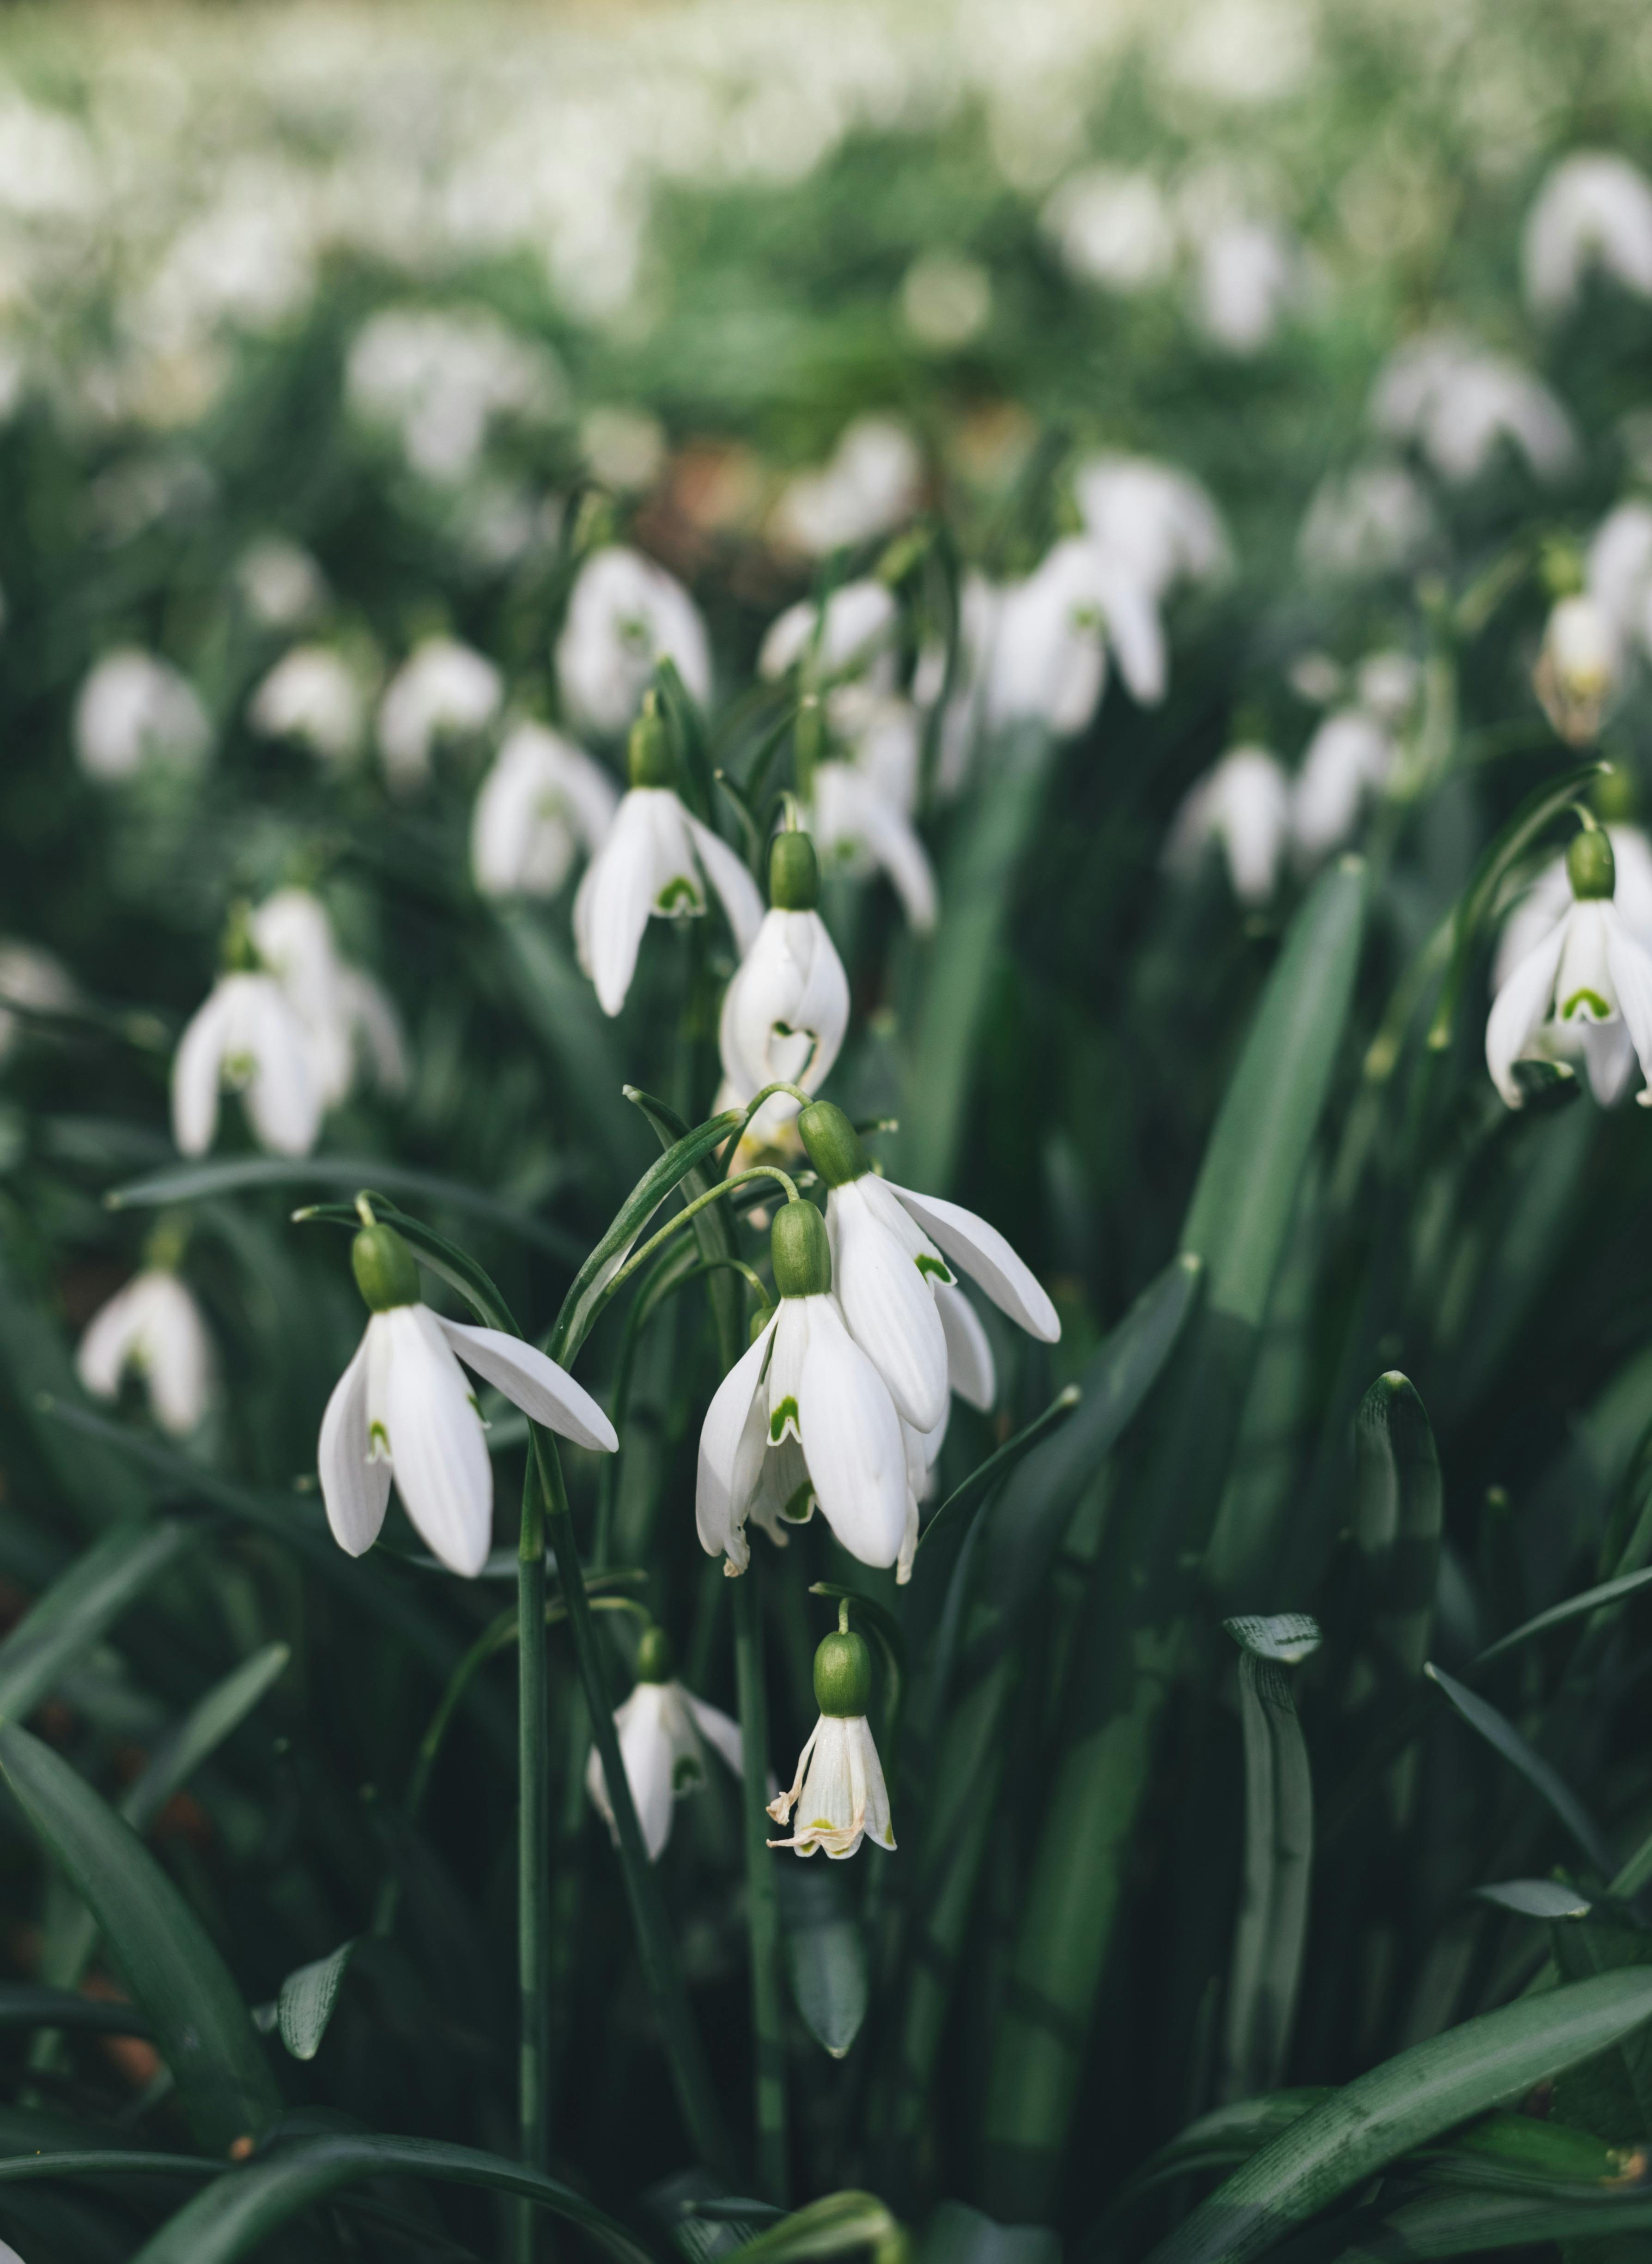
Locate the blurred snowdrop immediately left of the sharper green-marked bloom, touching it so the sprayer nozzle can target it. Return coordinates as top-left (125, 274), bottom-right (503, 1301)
top-left (471, 722), bottom-right (620, 896)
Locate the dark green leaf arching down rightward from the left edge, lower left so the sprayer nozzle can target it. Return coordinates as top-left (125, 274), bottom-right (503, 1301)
top-left (0, 1723), bottom-right (280, 2153)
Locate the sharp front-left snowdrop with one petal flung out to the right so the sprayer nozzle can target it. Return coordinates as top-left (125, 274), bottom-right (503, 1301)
top-left (317, 1200), bottom-right (618, 1578)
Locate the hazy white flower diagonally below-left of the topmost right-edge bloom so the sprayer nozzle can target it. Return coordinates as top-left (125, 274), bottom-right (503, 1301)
top-left (1372, 330), bottom-right (1577, 485)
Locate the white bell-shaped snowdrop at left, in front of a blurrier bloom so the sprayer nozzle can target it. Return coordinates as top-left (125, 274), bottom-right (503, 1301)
top-left (172, 974), bottom-right (326, 1155)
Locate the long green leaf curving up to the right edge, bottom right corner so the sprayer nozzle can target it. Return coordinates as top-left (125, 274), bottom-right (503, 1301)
top-left (1152, 1972), bottom-right (1652, 2264)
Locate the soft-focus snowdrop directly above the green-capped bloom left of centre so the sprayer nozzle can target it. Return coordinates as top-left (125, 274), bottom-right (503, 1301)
top-left (557, 543), bottom-right (711, 731)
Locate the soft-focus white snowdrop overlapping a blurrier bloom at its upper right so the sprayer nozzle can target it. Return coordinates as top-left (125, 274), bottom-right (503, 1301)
top-left (987, 536), bottom-right (1166, 738)
